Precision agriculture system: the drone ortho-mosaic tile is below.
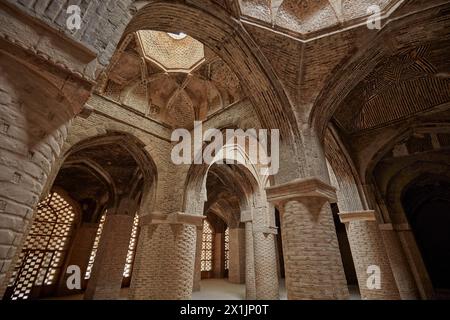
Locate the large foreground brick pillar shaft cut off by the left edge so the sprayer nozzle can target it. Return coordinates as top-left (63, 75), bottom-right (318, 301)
top-left (0, 54), bottom-right (73, 294)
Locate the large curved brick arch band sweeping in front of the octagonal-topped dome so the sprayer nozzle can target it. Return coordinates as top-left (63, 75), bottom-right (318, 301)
top-left (124, 0), bottom-right (298, 141)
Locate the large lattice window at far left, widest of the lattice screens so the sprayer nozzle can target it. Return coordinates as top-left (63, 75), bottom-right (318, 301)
top-left (9, 192), bottom-right (75, 300)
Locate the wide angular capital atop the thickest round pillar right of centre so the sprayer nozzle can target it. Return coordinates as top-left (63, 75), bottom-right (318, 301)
top-left (266, 177), bottom-right (337, 204)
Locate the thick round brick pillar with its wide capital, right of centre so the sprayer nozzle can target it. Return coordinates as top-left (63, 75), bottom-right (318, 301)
top-left (266, 178), bottom-right (349, 300)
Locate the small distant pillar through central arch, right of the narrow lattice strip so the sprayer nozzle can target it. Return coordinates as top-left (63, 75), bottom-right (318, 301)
top-left (228, 228), bottom-right (245, 283)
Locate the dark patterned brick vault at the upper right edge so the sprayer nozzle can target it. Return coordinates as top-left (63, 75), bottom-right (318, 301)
top-left (334, 41), bottom-right (450, 134)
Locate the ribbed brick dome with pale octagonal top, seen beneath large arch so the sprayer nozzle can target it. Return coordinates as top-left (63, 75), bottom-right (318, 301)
top-left (97, 31), bottom-right (244, 129)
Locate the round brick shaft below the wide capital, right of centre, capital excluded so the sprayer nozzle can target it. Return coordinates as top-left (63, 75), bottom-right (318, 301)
top-left (281, 199), bottom-right (348, 300)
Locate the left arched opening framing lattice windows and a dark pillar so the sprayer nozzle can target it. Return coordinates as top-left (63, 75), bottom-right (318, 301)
top-left (5, 132), bottom-right (156, 300)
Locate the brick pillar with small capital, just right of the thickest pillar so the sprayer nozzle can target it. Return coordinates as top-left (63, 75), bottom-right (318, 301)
top-left (339, 210), bottom-right (400, 300)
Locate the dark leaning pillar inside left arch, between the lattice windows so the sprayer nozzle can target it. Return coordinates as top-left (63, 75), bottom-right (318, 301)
top-left (84, 214), bottom-right (134, 300)
